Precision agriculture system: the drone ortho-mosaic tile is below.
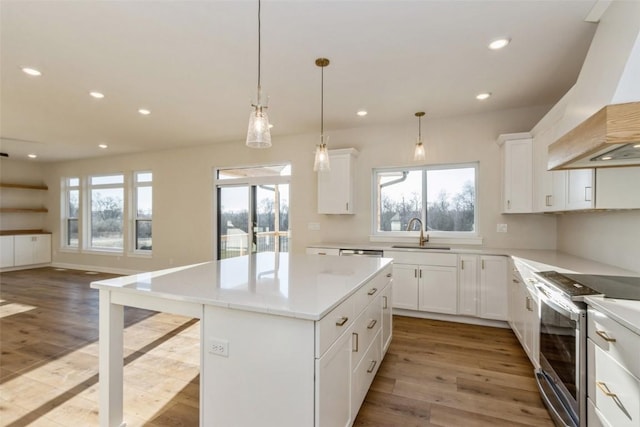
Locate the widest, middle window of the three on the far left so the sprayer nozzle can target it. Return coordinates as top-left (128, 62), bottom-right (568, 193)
top-left (88, 174), bottom-right (124, 251)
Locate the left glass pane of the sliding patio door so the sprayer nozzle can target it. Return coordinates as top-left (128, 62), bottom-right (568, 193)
top-left (218, 186), bottom-right (250, 259)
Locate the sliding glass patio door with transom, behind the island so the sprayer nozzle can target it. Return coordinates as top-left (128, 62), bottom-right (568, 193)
top-left (216, 164), bottom-right (291, 259)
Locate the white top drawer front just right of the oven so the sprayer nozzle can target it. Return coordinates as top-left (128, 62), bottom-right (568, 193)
top-left (587, 308), bottom-right (640, 378)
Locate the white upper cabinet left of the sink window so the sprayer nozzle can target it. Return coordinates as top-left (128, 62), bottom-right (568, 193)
top-left (318, 148), bottom-right (358, 214)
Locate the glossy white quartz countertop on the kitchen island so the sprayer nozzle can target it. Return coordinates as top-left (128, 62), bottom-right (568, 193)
top-left (91, 252), bottom-right (392, 320)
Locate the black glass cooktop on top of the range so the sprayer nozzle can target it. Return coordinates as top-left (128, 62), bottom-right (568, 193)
top-left (536, 271), bottom-right (640, 300)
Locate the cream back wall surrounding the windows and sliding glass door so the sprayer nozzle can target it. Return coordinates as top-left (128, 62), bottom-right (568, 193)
top-left (28, 107), bottom-right (556, 271)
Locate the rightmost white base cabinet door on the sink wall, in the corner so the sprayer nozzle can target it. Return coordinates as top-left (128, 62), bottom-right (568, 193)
top-left (480, 256), bottom-right (508, 320)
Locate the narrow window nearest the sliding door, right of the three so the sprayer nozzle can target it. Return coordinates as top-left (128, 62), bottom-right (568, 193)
top-left (133, 172), bottom-right (153, 252)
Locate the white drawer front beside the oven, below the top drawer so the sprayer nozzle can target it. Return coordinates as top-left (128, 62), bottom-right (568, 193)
top-left (587, 340), bottom-right (640, 427)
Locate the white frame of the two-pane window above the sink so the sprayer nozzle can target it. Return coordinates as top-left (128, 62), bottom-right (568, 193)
top-left (370, 162), bottom-right (482, 245)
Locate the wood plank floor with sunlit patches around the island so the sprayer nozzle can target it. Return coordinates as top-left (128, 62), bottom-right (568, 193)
top-left (0, 268), bottom-right (552, 427)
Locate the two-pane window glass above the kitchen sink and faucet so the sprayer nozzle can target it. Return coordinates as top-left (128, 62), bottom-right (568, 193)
top-left (372, 163), bottom-right (478, 238)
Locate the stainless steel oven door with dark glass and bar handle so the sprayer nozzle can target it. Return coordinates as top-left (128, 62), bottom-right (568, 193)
top-left (536, 285), bottom-right (586, 427)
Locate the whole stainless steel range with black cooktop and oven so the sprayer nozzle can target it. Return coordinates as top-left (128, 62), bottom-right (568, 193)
top-left (535, 271), bottom-right (640, 427)
